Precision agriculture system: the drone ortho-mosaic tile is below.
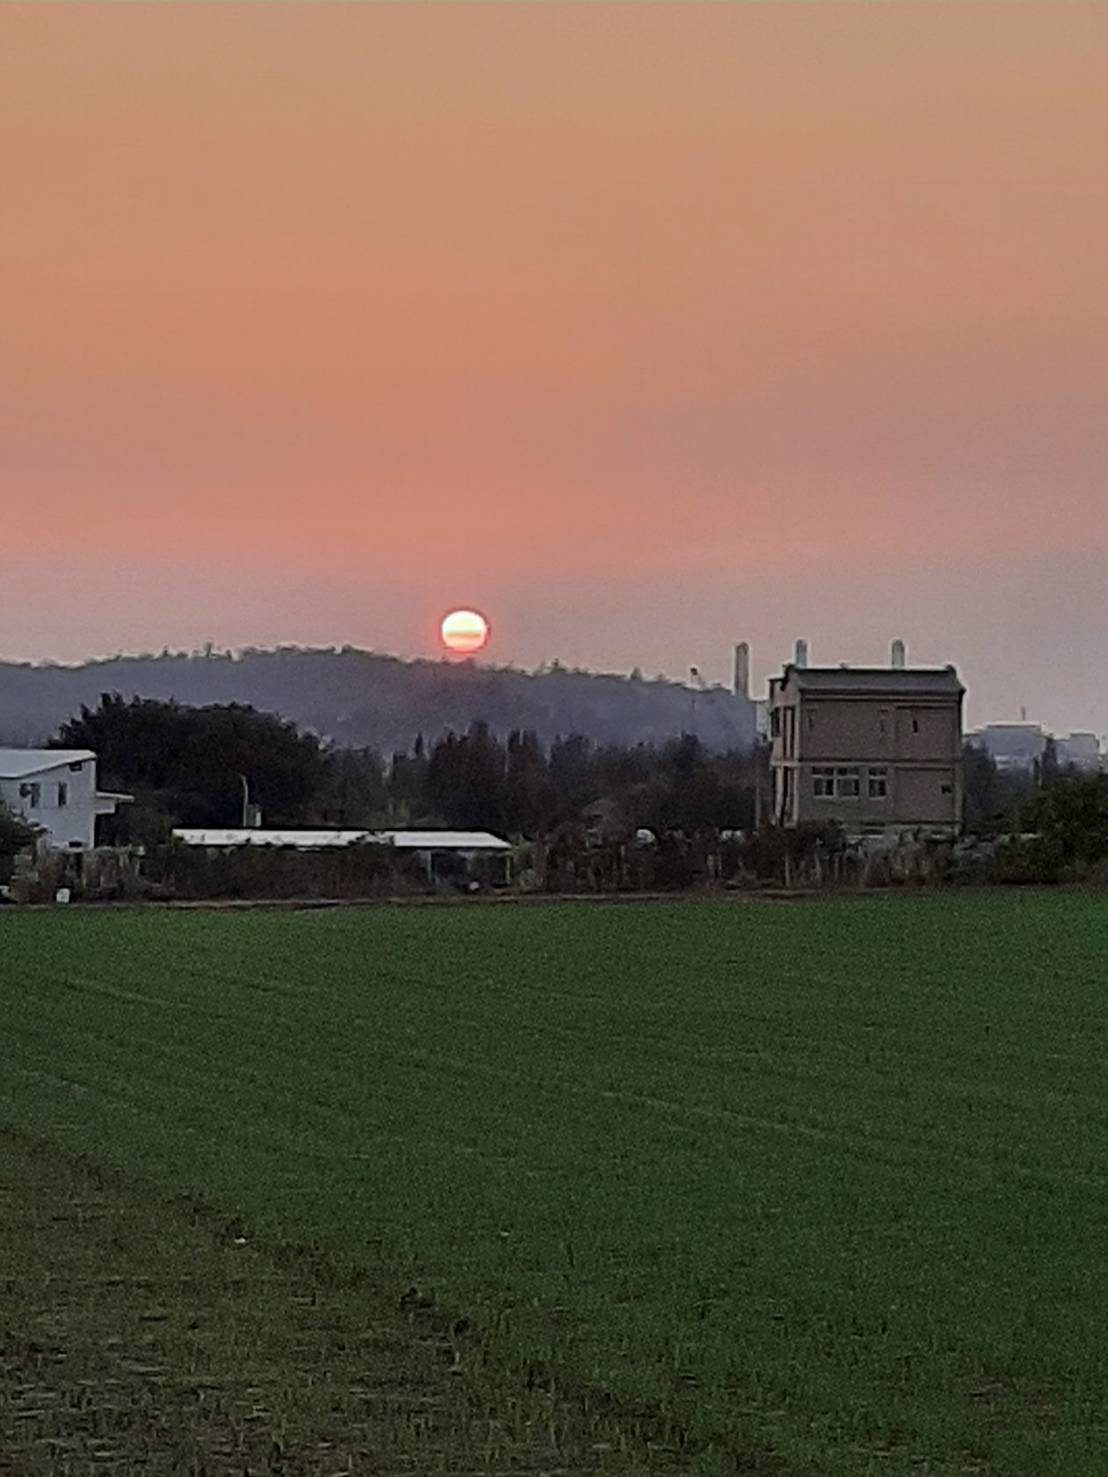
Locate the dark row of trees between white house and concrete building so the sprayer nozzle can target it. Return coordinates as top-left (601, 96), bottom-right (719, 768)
top-left (53, 694), bottom-right (765, 842)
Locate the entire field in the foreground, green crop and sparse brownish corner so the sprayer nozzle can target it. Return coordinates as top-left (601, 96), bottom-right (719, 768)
top-left (0, 892), bottom-right (1108, 1477)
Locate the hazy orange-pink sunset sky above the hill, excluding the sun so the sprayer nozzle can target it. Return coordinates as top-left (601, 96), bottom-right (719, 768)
top-left (0, 0), bottom-right (1108, 731)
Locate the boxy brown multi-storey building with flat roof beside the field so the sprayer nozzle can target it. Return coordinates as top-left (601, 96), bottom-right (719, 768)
top-left (770, 641), bottom-right (965, 836)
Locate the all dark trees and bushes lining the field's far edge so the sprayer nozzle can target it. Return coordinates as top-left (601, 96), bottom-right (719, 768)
top-left (10, 694), bottom-right (1108, 897)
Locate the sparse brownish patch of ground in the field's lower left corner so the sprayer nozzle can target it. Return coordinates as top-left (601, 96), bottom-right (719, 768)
top-left (0, 1128), bottom-right (747, 1477)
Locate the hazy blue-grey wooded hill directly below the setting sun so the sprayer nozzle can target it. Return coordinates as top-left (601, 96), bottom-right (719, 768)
top-left (0, 647), bottom-right (753, 752)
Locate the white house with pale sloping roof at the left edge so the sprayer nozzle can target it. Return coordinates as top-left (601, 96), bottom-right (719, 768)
top-left (0, 749), bottom-right (131, 851)
